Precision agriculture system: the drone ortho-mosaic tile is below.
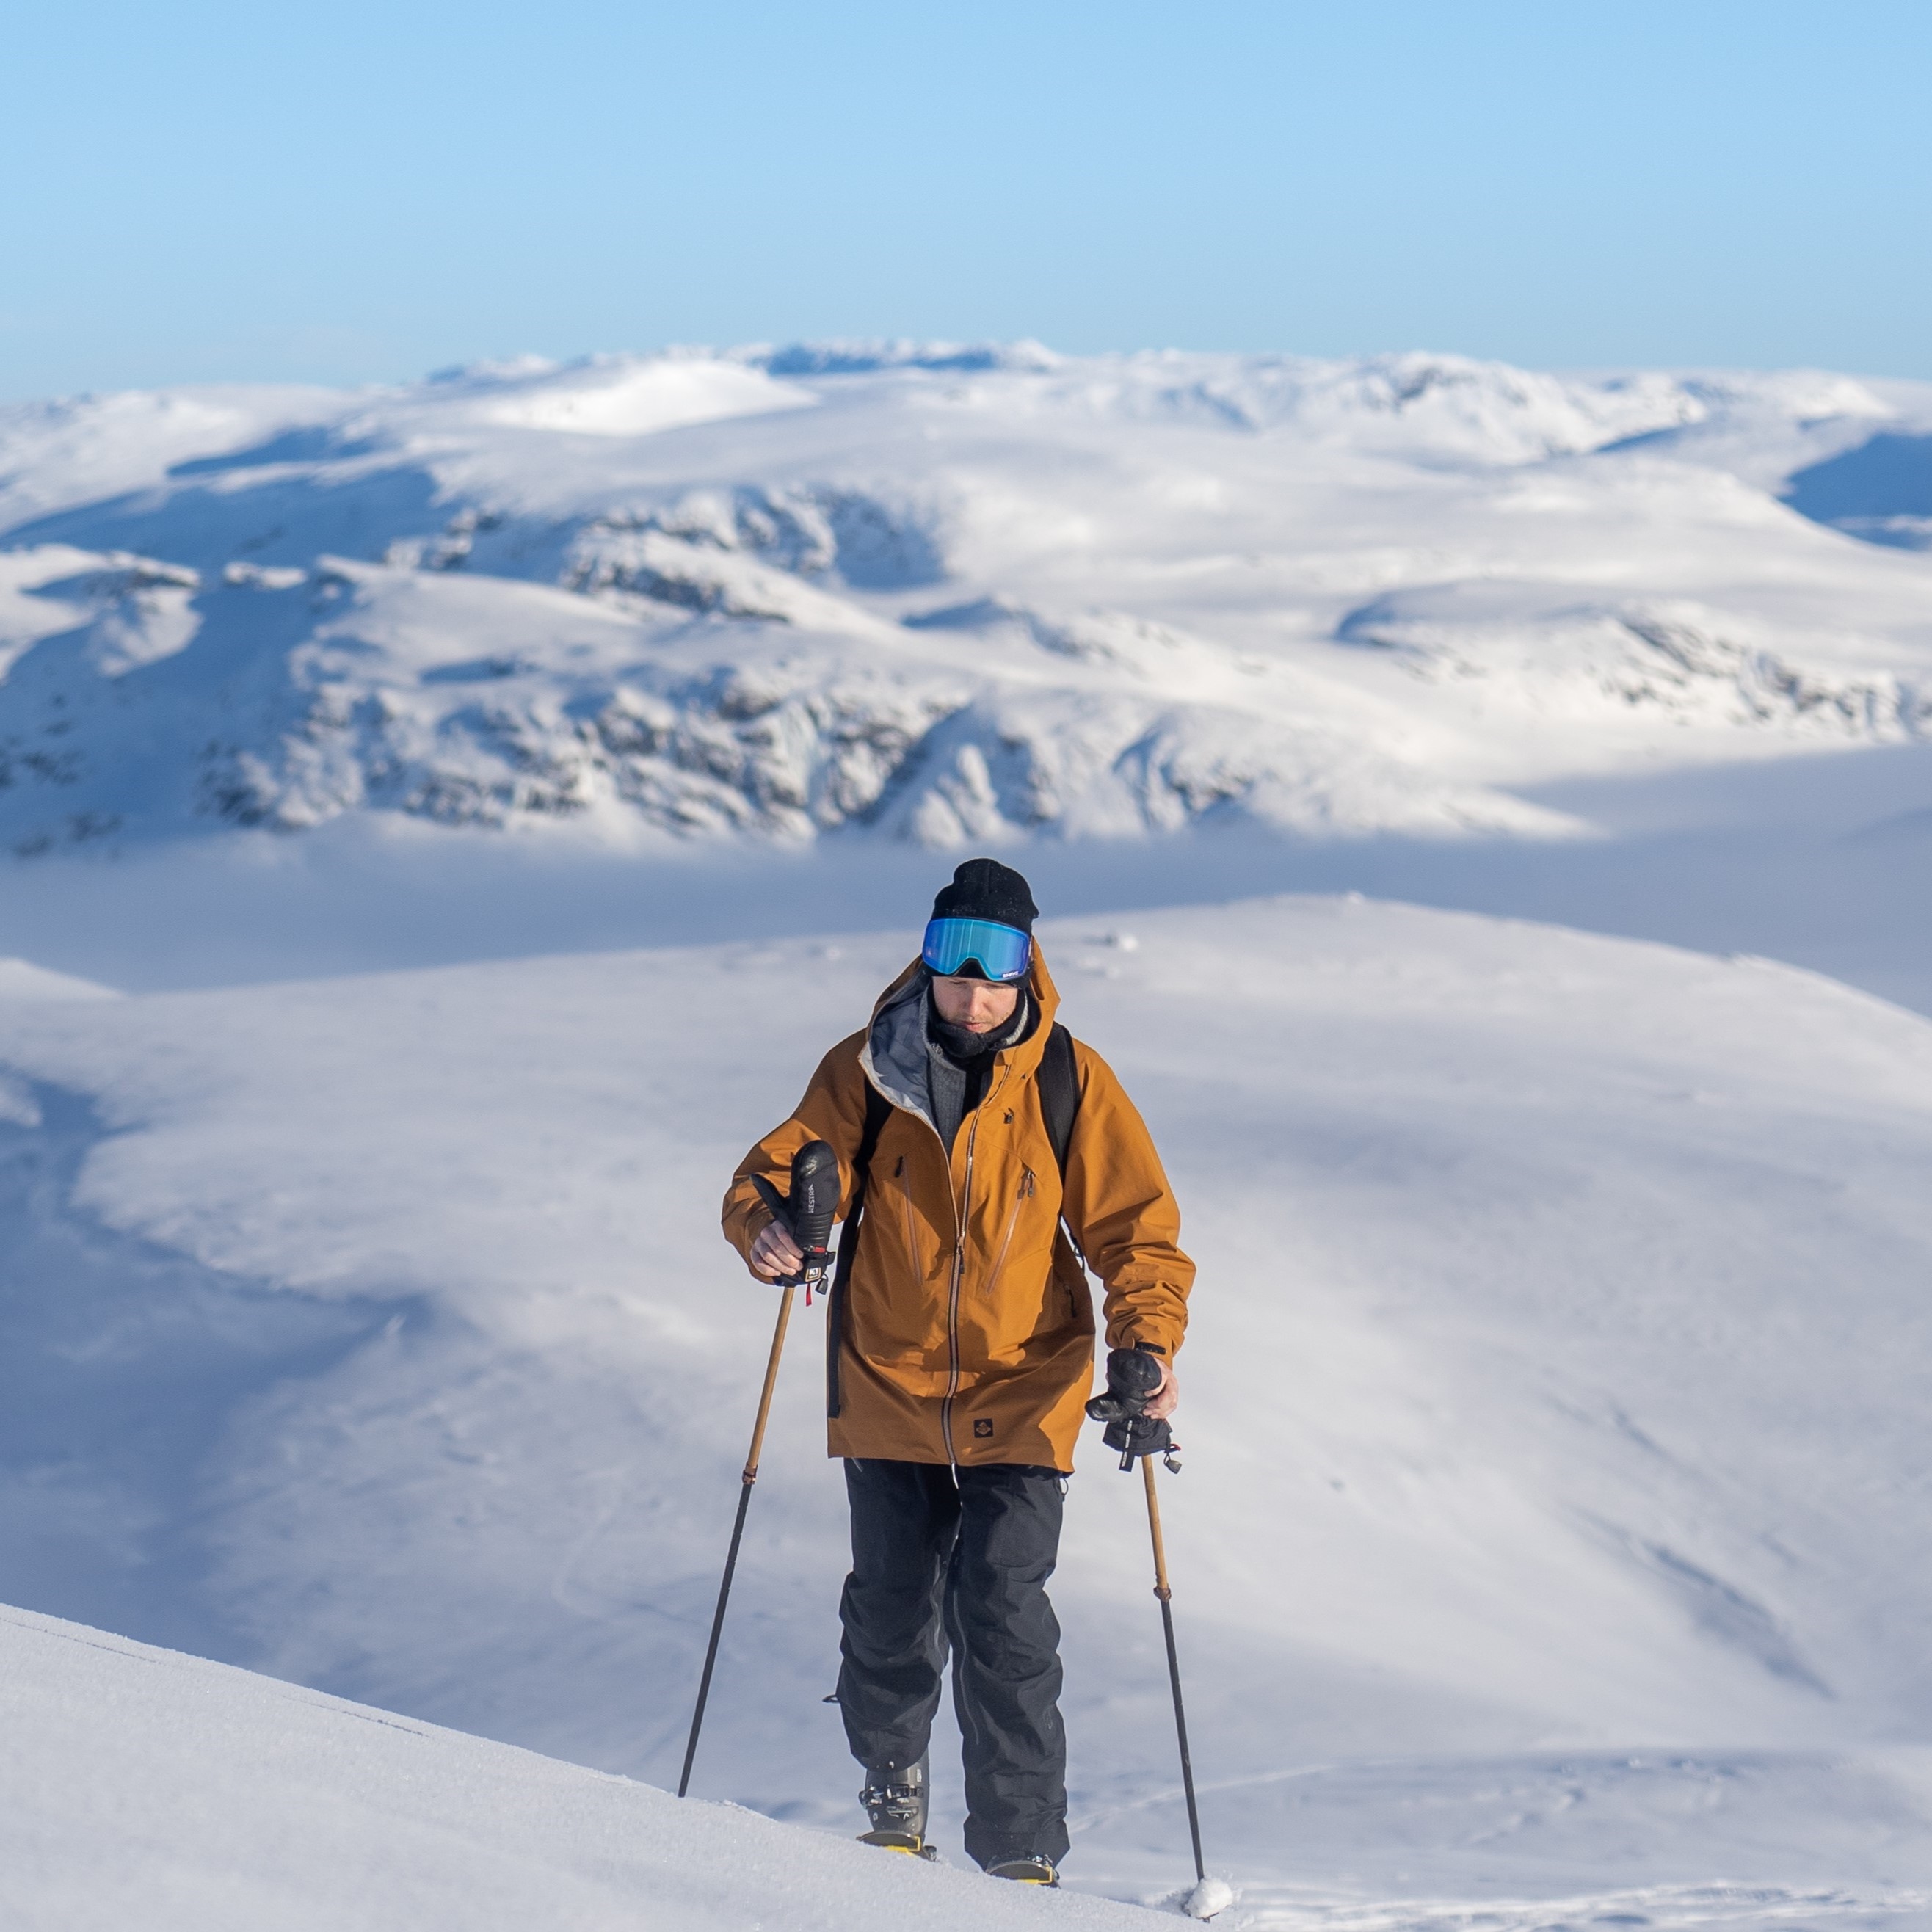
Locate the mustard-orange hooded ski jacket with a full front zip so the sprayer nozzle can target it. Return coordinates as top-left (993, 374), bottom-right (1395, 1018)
top-left (724, 947), bottom-right (1194, 1470)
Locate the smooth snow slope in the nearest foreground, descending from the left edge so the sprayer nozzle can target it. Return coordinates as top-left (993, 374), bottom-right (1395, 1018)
top-left (0, 1609), bottom-right (1146, 1932)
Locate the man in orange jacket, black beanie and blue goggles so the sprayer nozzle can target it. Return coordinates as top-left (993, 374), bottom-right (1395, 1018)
top-left (724, 858), bottom-right (1194, 1886)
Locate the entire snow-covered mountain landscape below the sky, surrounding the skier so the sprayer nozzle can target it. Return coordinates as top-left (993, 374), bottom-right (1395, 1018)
top-left (0, 344), bottom-right (1932, 1932)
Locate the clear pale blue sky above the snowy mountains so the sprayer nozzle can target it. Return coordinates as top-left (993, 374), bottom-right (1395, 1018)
top-left (0, 0), bottom-right (1932, 398)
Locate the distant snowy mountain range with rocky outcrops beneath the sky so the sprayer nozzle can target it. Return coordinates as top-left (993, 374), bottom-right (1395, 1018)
top-left (0, 344), bottom-right (1932, 858)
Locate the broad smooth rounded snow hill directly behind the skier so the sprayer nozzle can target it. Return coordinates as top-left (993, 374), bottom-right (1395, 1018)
top-left (0, 898), bottom-right (1932, 1926)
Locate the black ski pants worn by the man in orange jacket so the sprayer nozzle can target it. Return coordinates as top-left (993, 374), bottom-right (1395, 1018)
top-left (838, 1459), bottom-right (1067, 1864)
